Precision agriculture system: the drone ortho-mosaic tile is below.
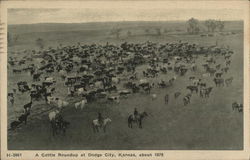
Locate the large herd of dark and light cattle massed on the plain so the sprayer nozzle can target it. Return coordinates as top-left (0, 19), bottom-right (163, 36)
top-left (8, 41), bottom-right (243, 134)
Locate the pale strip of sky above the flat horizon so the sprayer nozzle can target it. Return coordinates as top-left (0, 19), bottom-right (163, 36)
top-left (8, 3), bottom-right (243, 24)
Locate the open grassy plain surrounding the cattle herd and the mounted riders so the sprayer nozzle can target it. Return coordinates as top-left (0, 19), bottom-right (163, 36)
top-left (8, 22), bottom-right (243, 150)
